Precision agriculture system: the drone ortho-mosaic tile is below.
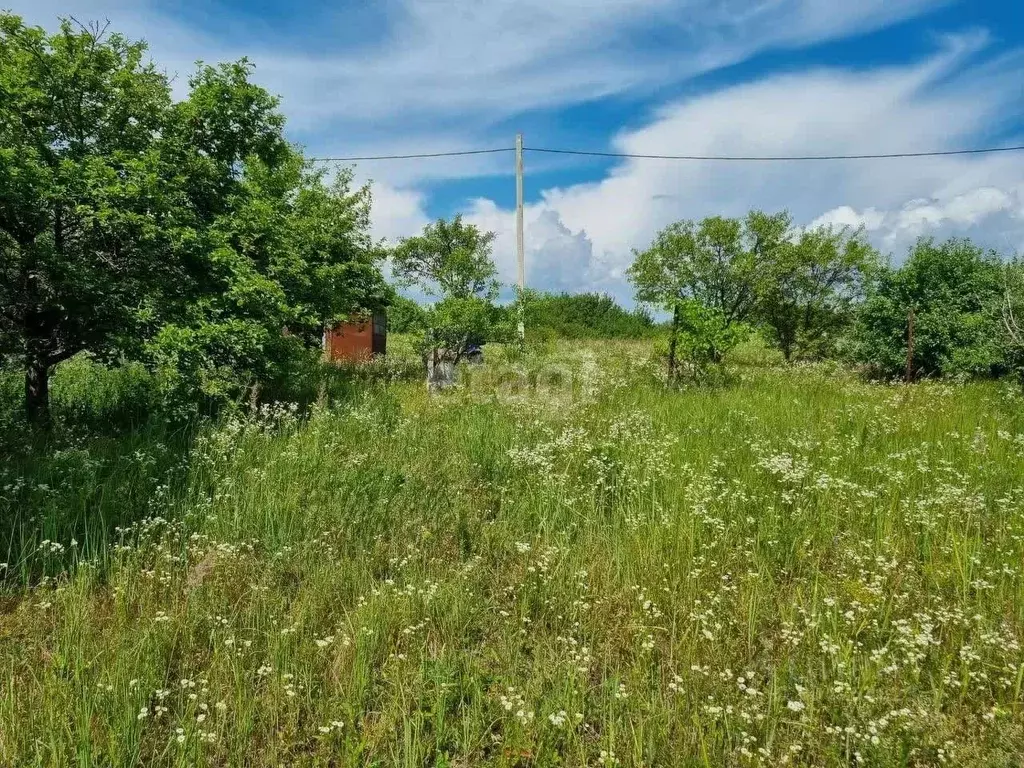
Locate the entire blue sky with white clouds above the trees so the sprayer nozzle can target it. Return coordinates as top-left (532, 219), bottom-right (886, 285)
top-left (8, 0), bottom-right (1024, 298)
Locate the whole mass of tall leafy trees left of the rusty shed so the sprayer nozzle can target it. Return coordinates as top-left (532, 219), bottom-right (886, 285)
top-left (0, 14), bottom-right (391, 421)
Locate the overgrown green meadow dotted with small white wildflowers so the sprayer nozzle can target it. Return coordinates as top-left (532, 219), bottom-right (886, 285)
top-left (0, 343), bottom-right (1024, 766)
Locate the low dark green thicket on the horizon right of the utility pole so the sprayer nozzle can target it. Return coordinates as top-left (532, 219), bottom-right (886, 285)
top-left (520, 291), bottom-right (655, 339)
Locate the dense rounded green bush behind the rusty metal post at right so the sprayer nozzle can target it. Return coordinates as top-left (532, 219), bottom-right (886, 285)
top-left (854, 239), bottom-right (1006, 377)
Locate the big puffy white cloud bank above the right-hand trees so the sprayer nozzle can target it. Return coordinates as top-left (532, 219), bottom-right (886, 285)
top-left (464, 35), bottom-right (1024, 293)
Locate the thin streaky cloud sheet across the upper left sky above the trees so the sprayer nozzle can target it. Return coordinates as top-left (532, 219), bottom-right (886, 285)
top-left (7, 0), bottom-right (944, 162)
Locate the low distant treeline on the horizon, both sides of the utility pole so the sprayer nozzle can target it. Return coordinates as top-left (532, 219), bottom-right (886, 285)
top-left (388, 291), bottom-right (657, 340)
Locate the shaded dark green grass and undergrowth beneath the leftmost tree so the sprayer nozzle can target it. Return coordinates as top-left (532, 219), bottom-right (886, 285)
top-left (0, 357), bottom-right (190, 583)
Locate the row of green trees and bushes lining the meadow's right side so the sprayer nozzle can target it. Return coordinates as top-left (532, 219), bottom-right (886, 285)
top-left (627, 211), bottom-right (1024, 383)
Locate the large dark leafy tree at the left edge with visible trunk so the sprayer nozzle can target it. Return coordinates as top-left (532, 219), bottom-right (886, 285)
top-left (0, 13), bottom-right (171, 422)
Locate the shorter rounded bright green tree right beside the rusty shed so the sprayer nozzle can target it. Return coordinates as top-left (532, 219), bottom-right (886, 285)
top-left (146, 158), bottom-right (390, 411)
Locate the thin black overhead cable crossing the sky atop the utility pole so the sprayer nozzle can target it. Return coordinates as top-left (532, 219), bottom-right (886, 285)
top-left (309, 144), bottom-right (1024, 163)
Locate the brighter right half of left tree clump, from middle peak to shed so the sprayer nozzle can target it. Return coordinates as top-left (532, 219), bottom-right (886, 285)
top-left (147, 60), bottom-right (391, 409)
